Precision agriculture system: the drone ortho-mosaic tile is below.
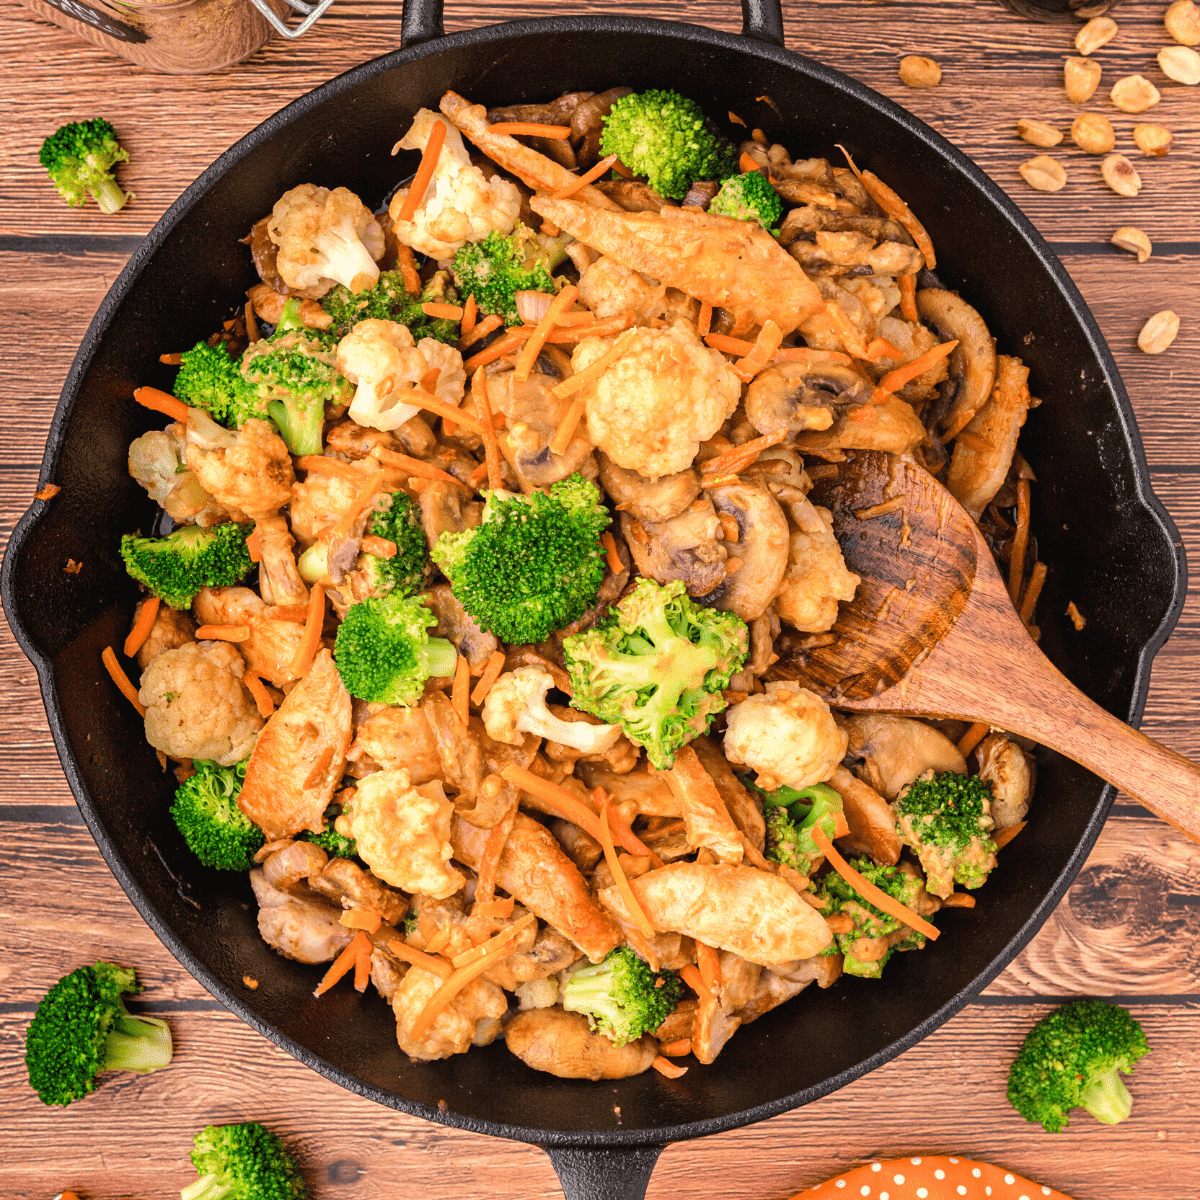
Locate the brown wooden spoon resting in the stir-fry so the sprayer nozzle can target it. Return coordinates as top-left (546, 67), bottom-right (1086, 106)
top-left (775, 451), bottom-right (1200, 841)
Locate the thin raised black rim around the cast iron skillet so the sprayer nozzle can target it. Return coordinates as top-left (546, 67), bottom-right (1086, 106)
top-left (0, 9), bottom-right (1187, 1148)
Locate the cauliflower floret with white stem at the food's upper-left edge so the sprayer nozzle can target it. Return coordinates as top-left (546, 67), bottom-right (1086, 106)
top-left (266, 184), bottom-right (384, 299)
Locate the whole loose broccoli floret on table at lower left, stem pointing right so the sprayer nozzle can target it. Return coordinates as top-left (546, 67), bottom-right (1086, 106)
top-left (25, 962), bottom-right (172, 1105)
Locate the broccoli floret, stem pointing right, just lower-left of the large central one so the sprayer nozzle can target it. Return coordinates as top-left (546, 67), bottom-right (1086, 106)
top-left (334, 594), bottom-right (458, 706)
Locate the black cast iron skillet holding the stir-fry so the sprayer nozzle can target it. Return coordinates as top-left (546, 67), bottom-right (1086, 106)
top-left (2, 0), bottom-right (1184, 1198)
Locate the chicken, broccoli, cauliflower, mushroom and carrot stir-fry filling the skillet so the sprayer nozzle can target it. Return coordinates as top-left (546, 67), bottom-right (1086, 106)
top-left (106, 88), bottom-right (1045, 1080)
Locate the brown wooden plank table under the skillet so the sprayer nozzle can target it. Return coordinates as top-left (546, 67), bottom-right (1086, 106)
top-left (0, 0), bottom-right (1200, 1200)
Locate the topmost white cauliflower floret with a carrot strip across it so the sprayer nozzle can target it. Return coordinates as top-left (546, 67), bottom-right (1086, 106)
top-left (388, 108), bottom-right (521, 262)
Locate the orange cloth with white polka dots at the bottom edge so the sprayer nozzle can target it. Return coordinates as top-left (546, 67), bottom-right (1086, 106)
top-left (792, 1154), bottom-right (1070, 1200)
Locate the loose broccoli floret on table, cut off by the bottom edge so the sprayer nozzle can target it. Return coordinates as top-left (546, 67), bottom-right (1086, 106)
top-left (179, 1121), bottom-right (305, 1200)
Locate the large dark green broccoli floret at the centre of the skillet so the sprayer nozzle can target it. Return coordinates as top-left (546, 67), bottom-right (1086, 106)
top-left (432, 475), bottom-right (610, 646)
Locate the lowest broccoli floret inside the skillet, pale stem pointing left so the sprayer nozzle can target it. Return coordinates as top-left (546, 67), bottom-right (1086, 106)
top-left (560, 946), bottom-right (680, 1046)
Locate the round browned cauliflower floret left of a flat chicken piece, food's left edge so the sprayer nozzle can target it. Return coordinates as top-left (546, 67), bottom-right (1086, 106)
top-left (138, 642), bottom-right (263, 767)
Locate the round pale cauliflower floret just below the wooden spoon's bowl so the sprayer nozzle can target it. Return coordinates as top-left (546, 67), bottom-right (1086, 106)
top-left (725, 682), bottom-right (848, 792)
